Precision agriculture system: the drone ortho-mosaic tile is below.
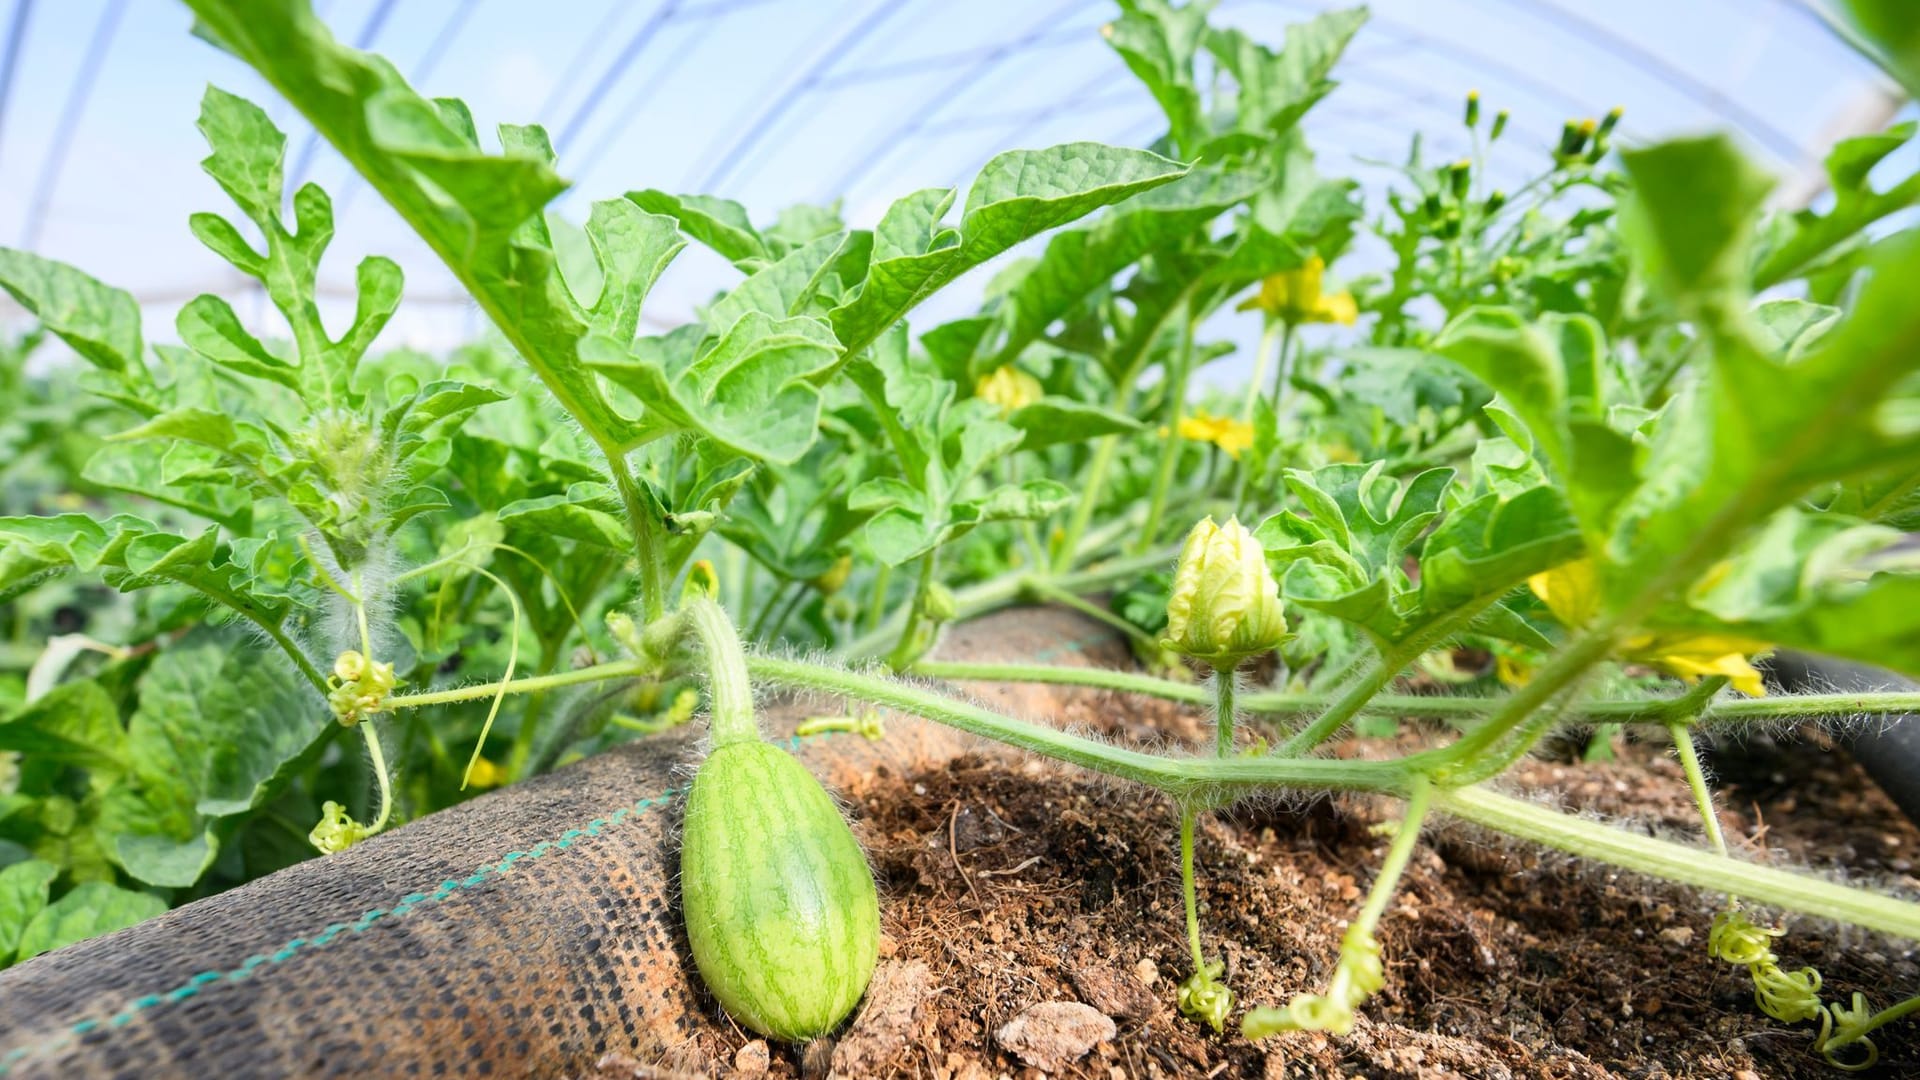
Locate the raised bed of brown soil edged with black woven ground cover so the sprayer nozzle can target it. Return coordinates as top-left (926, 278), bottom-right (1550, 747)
top-left (0, 609), bottom-right (1920, 1080)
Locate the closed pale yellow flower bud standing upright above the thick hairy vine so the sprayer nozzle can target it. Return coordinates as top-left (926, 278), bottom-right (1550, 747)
top-left (1162, 517), bottom-right (1286, 671)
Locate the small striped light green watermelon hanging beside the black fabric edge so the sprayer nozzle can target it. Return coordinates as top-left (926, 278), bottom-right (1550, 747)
top-left (680, 740), bottom-right (879, 1042)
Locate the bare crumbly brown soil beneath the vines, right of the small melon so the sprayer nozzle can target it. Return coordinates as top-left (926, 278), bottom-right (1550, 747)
top-left (668, 680), bottom-right (1920, 1080)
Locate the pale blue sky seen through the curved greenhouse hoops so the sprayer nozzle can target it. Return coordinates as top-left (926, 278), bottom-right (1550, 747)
top-left (0, 0), bottom-right (1916, 377)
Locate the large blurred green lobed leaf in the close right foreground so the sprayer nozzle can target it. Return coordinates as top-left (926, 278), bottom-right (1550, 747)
top-left (1599, 142), bottom-right (1920, 592)
